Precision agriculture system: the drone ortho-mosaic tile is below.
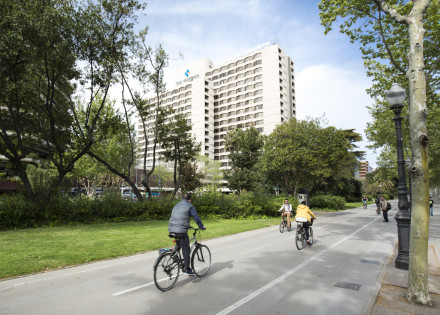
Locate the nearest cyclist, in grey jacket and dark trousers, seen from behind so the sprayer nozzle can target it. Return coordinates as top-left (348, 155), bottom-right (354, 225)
top-left (168, 194), bottom-right (206, 276)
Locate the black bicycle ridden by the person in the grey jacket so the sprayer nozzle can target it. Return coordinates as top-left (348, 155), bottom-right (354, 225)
top-left (153, 227), bottom-right (211, 292)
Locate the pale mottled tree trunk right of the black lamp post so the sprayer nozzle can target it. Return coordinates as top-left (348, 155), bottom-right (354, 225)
top-left (406, 0), bottom-right (431, 305)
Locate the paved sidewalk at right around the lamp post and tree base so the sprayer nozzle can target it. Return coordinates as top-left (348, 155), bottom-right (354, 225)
top-left (370, 204), bottom-right (440, 315)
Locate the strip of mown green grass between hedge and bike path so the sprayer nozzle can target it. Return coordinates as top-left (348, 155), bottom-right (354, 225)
top-left (0, 218), bottom-right (279, 279)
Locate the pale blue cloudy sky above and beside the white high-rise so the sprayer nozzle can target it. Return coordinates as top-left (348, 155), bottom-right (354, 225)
top-left (139, 0), bottom-right (379, 167)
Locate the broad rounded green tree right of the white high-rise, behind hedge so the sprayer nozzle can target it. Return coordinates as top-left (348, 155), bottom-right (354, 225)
top-left (263, 119), bottom-right (353, 196)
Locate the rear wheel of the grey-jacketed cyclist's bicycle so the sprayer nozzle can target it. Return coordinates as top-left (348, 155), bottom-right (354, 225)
top-left (154, 253), bottom-right (180, 291)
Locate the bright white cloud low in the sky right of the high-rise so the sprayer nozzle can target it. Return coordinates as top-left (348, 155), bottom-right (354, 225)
top-left (295, 64), bottom-right (377, 165)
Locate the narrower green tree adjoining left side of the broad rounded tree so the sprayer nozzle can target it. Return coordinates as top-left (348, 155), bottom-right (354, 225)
top-left (225, 127), bottom-right (264, 193)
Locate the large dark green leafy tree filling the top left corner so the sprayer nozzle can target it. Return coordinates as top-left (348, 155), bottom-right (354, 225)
top-left (0, 0), bottom-right (144, 198)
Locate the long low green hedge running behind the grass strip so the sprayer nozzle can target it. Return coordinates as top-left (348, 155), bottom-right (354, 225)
top-left (0, 193), bottom-right (298, 229)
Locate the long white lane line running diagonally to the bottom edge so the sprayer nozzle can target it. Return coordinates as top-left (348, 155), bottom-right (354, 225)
top-left (217, 218), bottom-right (378, 315)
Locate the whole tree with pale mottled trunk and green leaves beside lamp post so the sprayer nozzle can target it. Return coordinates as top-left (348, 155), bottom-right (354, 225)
top-left (319, 0), bottom-right (434, 305)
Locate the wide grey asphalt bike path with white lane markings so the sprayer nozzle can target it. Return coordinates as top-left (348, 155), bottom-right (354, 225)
top-left (0, 204), bottom-right (397, 314)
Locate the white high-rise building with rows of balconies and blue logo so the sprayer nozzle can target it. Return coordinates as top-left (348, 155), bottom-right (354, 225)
top-left (138, 43), bottom-right (296, 168)
